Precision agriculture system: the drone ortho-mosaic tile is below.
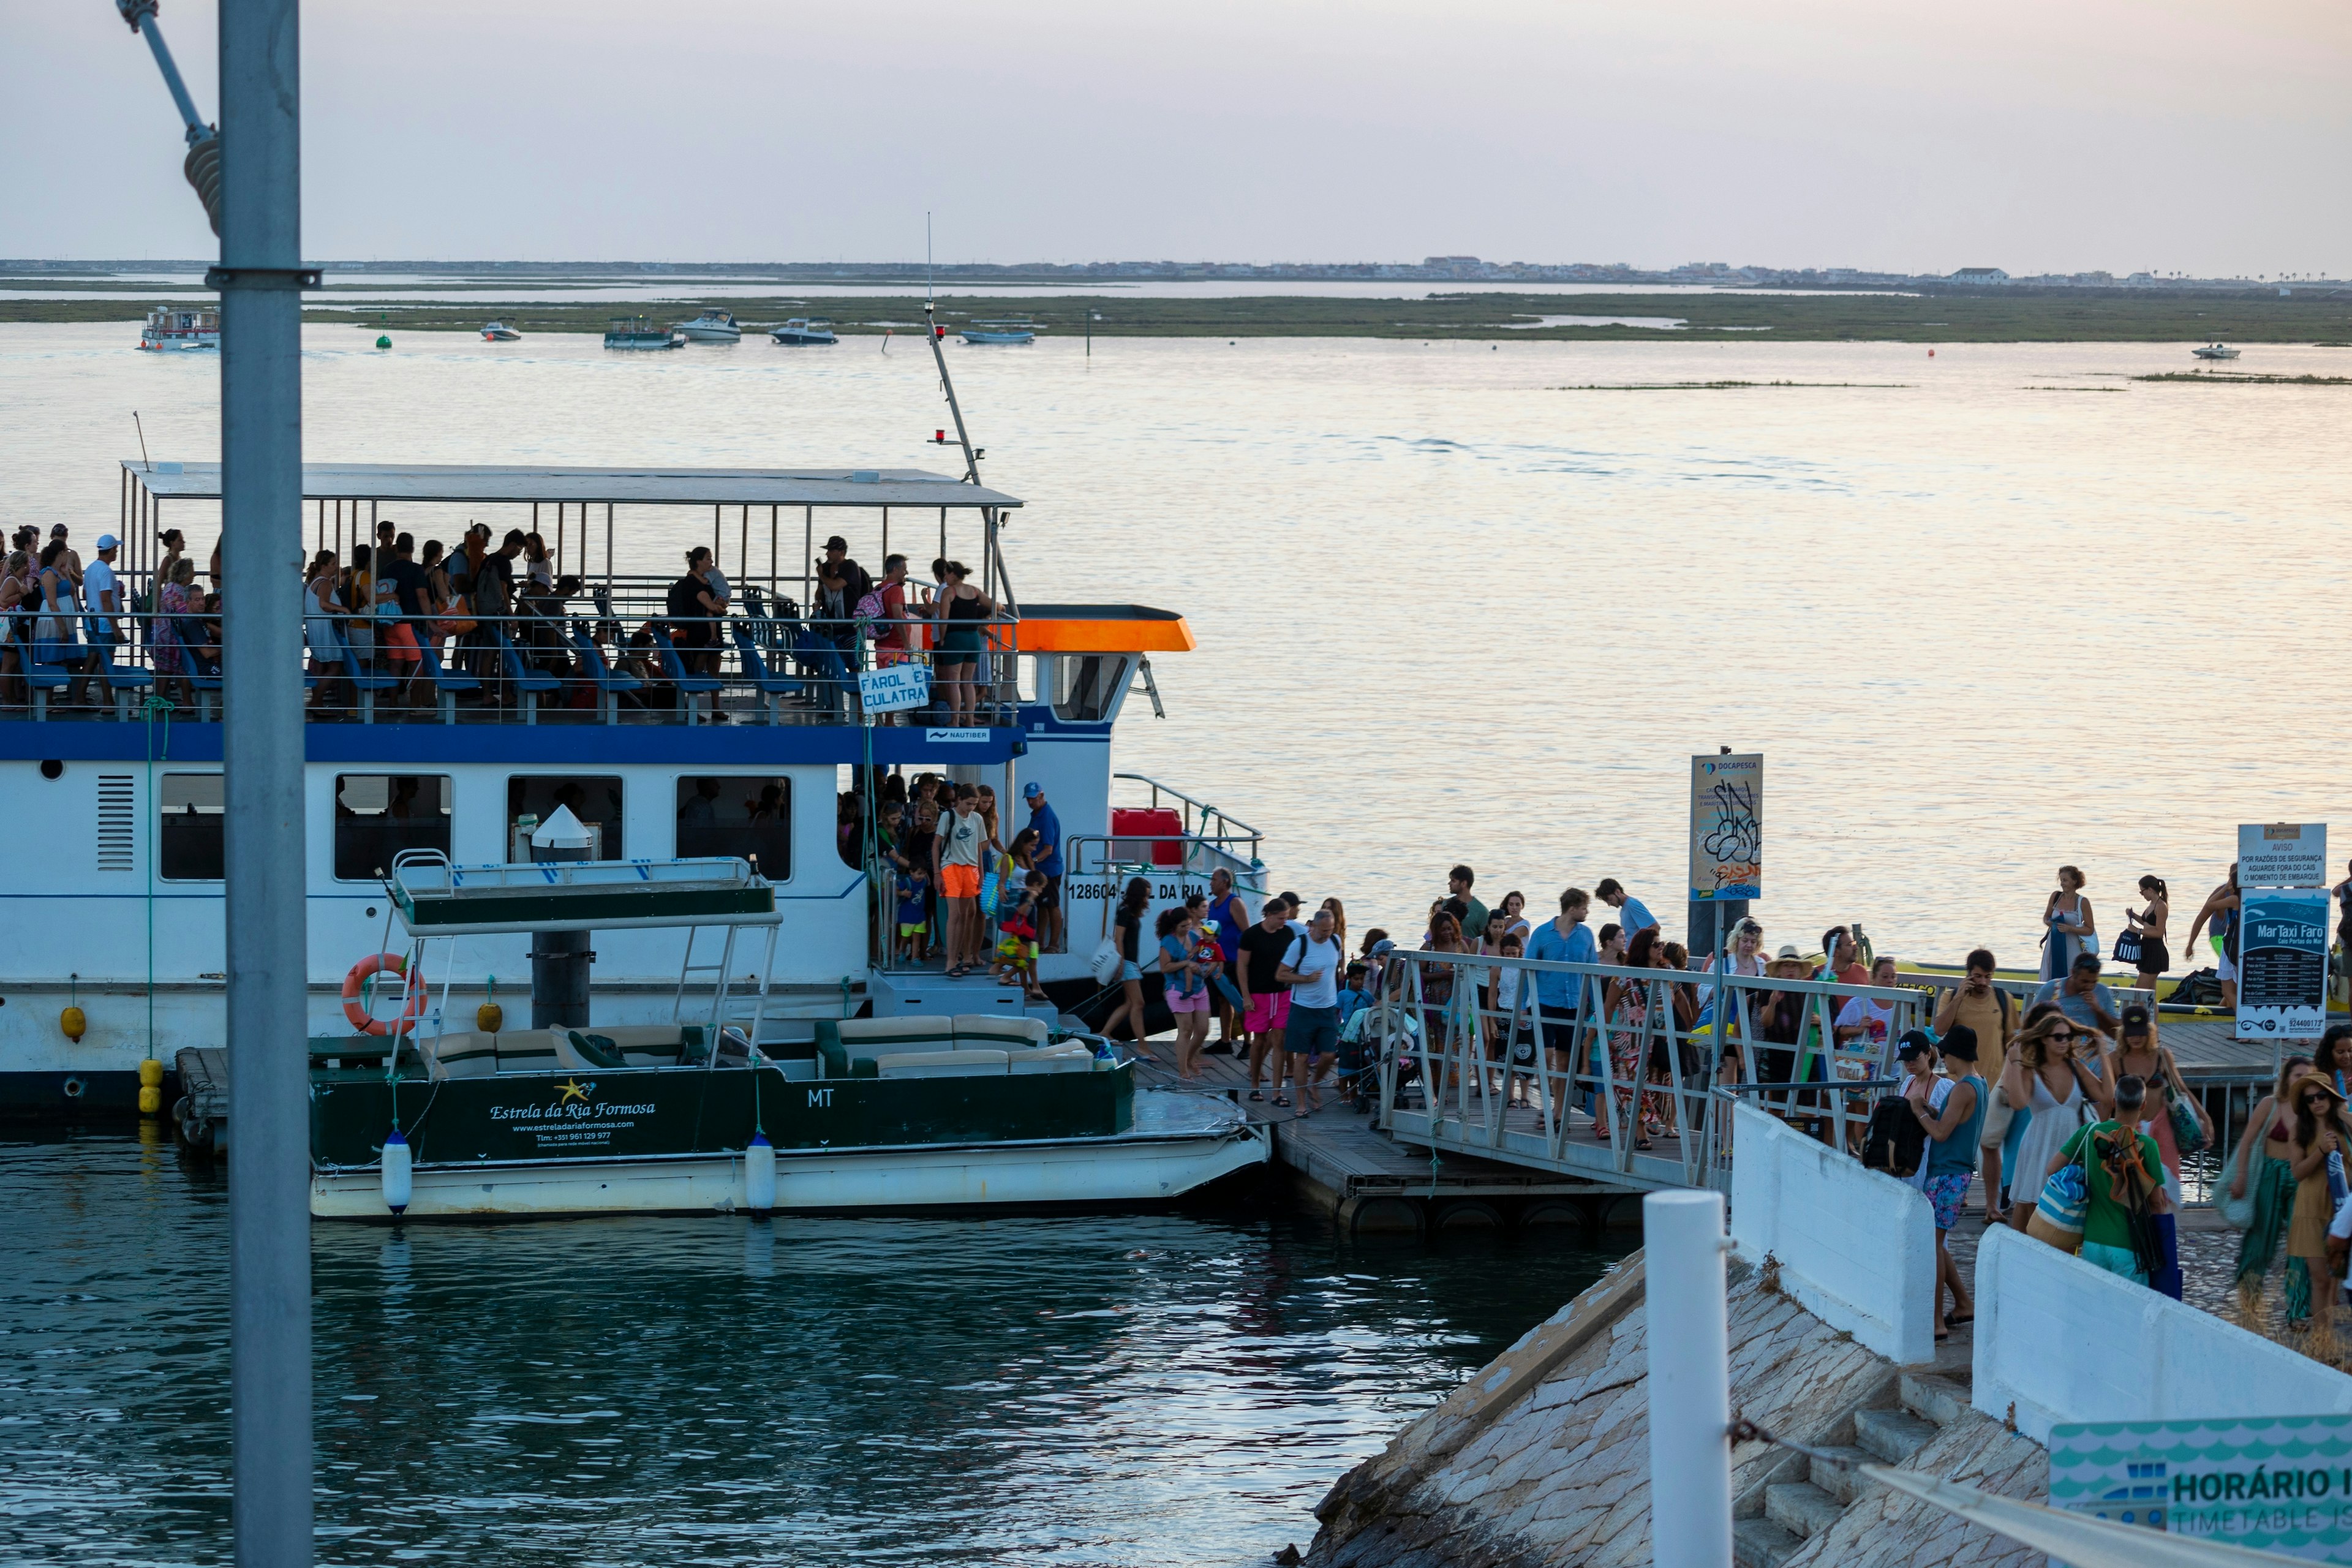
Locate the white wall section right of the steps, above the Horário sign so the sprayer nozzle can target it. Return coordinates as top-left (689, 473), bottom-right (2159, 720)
top-left (1971, 1225), bottom-right (2352, 1444)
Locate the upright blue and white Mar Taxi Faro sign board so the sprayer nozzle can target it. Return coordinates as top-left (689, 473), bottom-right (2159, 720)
top-left (2237, 823), bottom-right (2329, 1039)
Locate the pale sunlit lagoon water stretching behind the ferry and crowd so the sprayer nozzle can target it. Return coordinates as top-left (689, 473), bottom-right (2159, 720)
top-left (0, 325), bottom-right (2352, 962)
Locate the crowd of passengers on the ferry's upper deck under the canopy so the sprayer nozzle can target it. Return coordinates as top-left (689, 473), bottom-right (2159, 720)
top-left (0, 522), bottom-right (1005, 724)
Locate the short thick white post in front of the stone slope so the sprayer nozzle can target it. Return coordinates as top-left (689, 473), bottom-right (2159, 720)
top-left (1642, 1192), bottom-right (1731, 1568)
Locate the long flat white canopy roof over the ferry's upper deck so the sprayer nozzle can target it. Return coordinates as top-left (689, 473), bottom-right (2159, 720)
top-left (123, 458), bottom-right (1021, 508)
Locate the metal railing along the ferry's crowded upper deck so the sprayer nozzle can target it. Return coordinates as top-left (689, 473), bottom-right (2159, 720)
top-left (0, 578), bottom-right (1019, 726)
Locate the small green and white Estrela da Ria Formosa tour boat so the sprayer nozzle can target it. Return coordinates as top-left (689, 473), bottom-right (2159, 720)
top-left (311, 851), bottom-right (1268, 1220)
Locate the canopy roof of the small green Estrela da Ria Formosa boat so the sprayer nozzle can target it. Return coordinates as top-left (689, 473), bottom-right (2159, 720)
top-left (390, 856), bottom-right (783, 936)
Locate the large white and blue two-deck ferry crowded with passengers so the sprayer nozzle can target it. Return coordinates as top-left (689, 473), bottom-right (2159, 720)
top-left (0, 458), bottom-right (1265, 1117)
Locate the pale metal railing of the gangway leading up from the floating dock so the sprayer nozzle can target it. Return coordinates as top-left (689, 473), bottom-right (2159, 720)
top-left (1366, 950), bottom-right (1926, 1187)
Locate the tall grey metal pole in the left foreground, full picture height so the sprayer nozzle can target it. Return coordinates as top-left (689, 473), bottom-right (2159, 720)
top-left (216, 0), bottom-right (311, 1568)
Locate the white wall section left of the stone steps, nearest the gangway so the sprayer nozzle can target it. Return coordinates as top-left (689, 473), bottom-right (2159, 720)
top-left (1731, 1105), bottom-right (1938, 1366)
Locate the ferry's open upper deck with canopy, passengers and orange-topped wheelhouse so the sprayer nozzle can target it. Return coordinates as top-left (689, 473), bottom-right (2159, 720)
top-left (0, 461), bottom-right (1193, 762)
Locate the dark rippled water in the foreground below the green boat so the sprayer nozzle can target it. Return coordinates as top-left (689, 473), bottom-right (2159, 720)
top-left (0, 1136), bottom-right (1607, 1568)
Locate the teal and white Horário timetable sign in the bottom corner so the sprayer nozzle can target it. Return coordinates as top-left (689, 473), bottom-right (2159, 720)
top-left (2051, 1415), bottom-right (2352, 1563)
